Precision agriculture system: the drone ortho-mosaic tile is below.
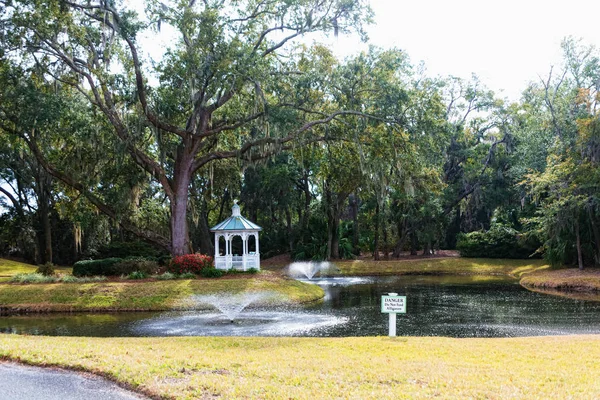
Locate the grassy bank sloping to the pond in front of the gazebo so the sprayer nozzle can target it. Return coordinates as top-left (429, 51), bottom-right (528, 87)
top-left (0, 272), bottom-right (323, 311)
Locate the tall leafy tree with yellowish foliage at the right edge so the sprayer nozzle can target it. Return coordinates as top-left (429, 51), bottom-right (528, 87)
top-left (521, 38), bottom-right (600, 269)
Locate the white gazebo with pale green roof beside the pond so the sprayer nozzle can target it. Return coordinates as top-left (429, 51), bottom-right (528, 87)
top-left (210, 200), bottom-right (262, 271)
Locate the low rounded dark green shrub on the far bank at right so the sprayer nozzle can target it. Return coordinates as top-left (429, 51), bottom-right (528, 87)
top-left (456, 225), bottom-right (537, 258)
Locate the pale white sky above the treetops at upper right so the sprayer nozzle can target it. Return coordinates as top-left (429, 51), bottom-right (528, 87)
top-left (327, 0), bottom-right (600, 101)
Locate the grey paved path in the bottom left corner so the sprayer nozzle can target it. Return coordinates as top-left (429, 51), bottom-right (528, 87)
top-left (0, 363), bottom-right (146, 400)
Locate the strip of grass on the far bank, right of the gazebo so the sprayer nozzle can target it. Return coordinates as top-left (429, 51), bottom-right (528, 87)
top-left (335, 257), bottom-right (549, 278)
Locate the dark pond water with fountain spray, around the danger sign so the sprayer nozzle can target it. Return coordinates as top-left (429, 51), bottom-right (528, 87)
top-left (0, 276), bottom-right (600, 337)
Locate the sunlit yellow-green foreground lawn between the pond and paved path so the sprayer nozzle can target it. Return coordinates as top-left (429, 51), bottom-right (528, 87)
top-left (0, 334), bottom-right (600, 399)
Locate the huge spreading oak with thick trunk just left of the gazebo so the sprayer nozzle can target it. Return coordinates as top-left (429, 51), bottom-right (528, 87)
top-left (2, 0), bottom-right (370, 255)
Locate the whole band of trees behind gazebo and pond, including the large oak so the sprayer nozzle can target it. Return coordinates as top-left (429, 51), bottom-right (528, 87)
top-left (0, 0), bottom-right (600, 268)
